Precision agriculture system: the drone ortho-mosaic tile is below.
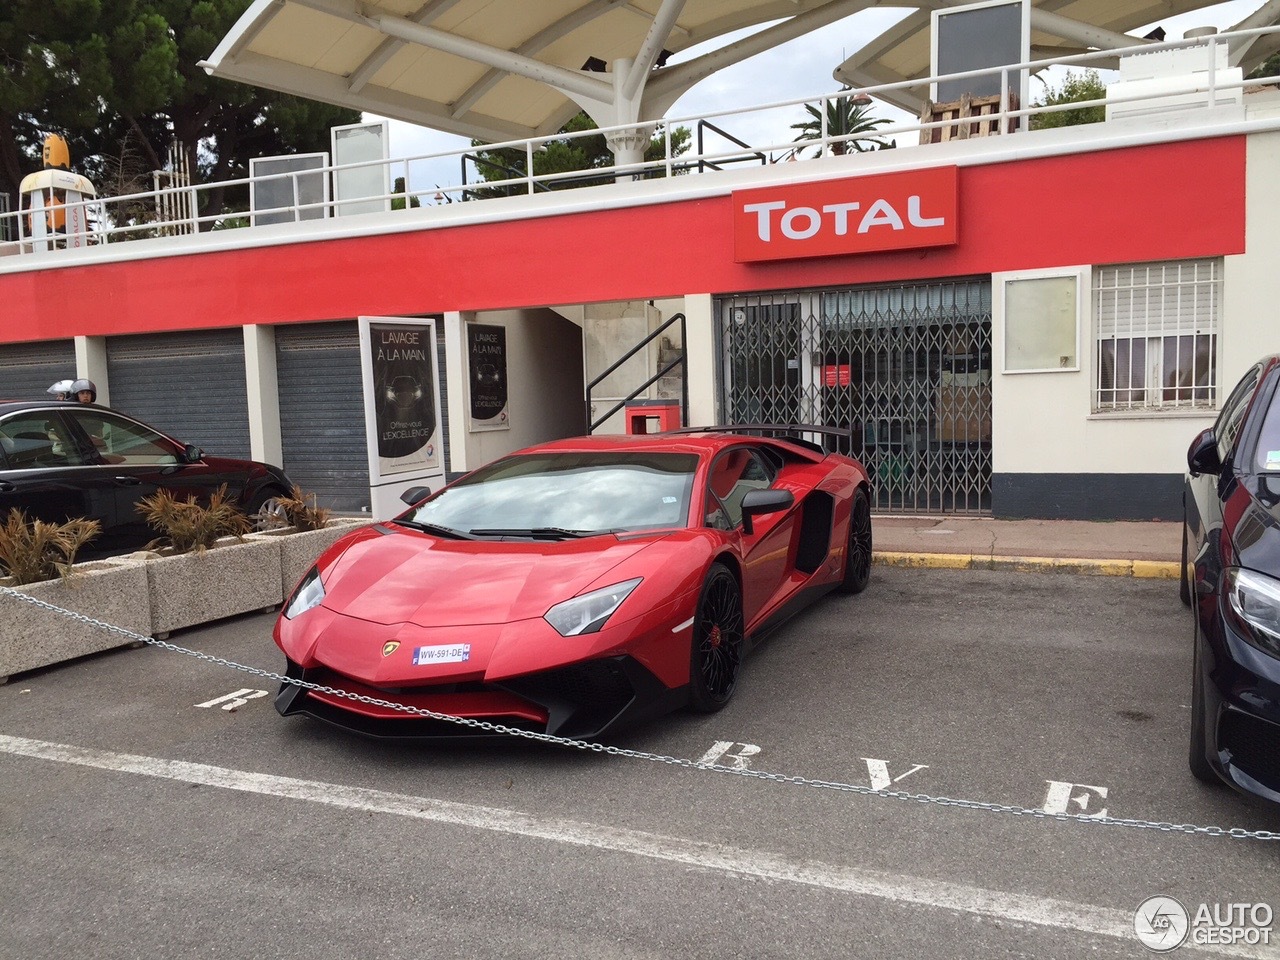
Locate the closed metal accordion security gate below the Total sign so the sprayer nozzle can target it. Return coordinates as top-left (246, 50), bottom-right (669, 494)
top-left (717, 278), bottom-right (992, 515)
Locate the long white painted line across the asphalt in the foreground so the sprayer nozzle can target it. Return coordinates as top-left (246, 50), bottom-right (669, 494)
top-left (0, 735), bottom-right (1259, 957)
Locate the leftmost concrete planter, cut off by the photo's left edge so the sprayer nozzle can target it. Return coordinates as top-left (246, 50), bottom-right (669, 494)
top-left (0, 561), bottom-right (151, 680)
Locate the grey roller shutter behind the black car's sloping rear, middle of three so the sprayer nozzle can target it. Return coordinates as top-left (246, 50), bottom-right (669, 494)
top-left (106, 326), bottom-right (250, 458)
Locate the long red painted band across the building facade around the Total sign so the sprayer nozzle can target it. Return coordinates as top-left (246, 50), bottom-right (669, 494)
top-left (0, 137), bottom-right (1245, 342)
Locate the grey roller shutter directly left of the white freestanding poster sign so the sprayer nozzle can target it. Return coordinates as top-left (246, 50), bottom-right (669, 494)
top-left (275, 320), bottom-right (369, 511)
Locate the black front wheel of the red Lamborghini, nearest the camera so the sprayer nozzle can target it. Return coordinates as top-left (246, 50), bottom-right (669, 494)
top-left (689, 563), bottom-right (745, 713)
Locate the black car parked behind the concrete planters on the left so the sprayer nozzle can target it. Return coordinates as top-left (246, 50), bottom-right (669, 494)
top-left (0, 401), bottom-right (292, 559)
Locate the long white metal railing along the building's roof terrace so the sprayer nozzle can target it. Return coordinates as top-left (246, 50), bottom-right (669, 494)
top-left (0, 27), bottom-right (1280, 256)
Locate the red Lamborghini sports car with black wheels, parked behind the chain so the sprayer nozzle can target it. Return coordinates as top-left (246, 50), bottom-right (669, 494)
top-left (275, 426), bottom-right (872, 739)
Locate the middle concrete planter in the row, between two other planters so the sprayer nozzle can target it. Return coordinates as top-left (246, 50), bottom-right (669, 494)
top-left (142, 538), bottom-right (284, 636)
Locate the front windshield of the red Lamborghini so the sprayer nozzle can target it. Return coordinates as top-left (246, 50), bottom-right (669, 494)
top-left (402, 452), bottom-right (698, 539)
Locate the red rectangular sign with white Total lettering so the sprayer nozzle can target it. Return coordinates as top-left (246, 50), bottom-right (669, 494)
top-left (733, 166), bottom-right (959, 264)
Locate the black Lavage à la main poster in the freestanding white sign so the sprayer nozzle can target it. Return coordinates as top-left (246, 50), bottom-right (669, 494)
top-left (369, 321), bottom-right (440, 477)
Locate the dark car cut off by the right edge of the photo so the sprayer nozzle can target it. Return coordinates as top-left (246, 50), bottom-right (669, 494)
top-left (1181, 356), bottom-right (1280, 801)
